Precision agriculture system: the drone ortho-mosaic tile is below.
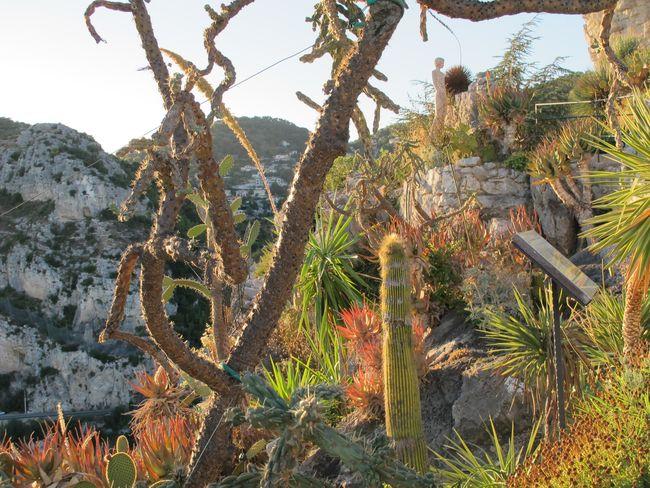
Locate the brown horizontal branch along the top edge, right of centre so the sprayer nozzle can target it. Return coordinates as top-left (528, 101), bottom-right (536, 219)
top-left (418, 0), bottom-right (618, 22)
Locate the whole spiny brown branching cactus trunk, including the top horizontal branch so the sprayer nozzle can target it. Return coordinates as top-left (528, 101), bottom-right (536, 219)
top-left (85, 0), bottom-right (616, 487)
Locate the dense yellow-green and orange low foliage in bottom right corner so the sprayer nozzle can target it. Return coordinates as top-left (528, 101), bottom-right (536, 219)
top-left (508, 362), bottom-right (650, 488)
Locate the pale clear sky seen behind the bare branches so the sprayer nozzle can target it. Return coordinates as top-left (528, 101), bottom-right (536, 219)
top-left (0, 0), bottom-right (591, 152)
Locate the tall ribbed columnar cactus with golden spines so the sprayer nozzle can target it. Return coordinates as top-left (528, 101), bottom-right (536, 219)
top-left (379, 234), bottom-right (427, 473)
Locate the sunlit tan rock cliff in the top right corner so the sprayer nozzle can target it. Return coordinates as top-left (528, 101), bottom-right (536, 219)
top-left (584, 0), bottom-right (650, 62)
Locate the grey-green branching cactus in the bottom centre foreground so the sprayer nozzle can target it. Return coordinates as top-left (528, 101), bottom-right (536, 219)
top-left (210, 373), bottom-right (435, 488)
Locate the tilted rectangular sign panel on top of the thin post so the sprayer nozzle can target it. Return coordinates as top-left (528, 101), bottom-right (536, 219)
top-left (512, 230), bottom-right (599, 305)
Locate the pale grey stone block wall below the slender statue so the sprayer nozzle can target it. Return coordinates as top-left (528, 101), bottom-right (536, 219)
top-left (402, 157), bottom-right (531, 219)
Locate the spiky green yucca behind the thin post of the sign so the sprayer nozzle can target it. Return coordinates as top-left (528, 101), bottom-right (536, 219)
top-left (482, 286), bottom-right (588, 434)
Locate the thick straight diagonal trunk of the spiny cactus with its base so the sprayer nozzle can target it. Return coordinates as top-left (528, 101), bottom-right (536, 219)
top-left (186, 1), bottom-right (403, 488)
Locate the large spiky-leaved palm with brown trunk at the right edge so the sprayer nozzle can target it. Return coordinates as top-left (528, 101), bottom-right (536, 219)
top-left (584, 91), bottom-right (650, 366)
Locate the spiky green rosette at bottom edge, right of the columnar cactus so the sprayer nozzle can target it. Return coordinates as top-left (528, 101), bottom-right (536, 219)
top-left (433, 419), bottom-right (541, 488)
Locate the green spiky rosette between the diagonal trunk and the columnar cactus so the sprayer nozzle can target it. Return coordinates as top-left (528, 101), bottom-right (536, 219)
top-left (298, 208), bottom-right (365, 327)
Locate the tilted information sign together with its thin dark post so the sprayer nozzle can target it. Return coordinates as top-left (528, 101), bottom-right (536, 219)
top-left (512, 230), bottom-right (599, 431)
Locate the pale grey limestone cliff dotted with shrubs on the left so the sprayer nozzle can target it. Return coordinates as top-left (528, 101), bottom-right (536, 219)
top-left (0, 124), bottom-right (150, 412)
